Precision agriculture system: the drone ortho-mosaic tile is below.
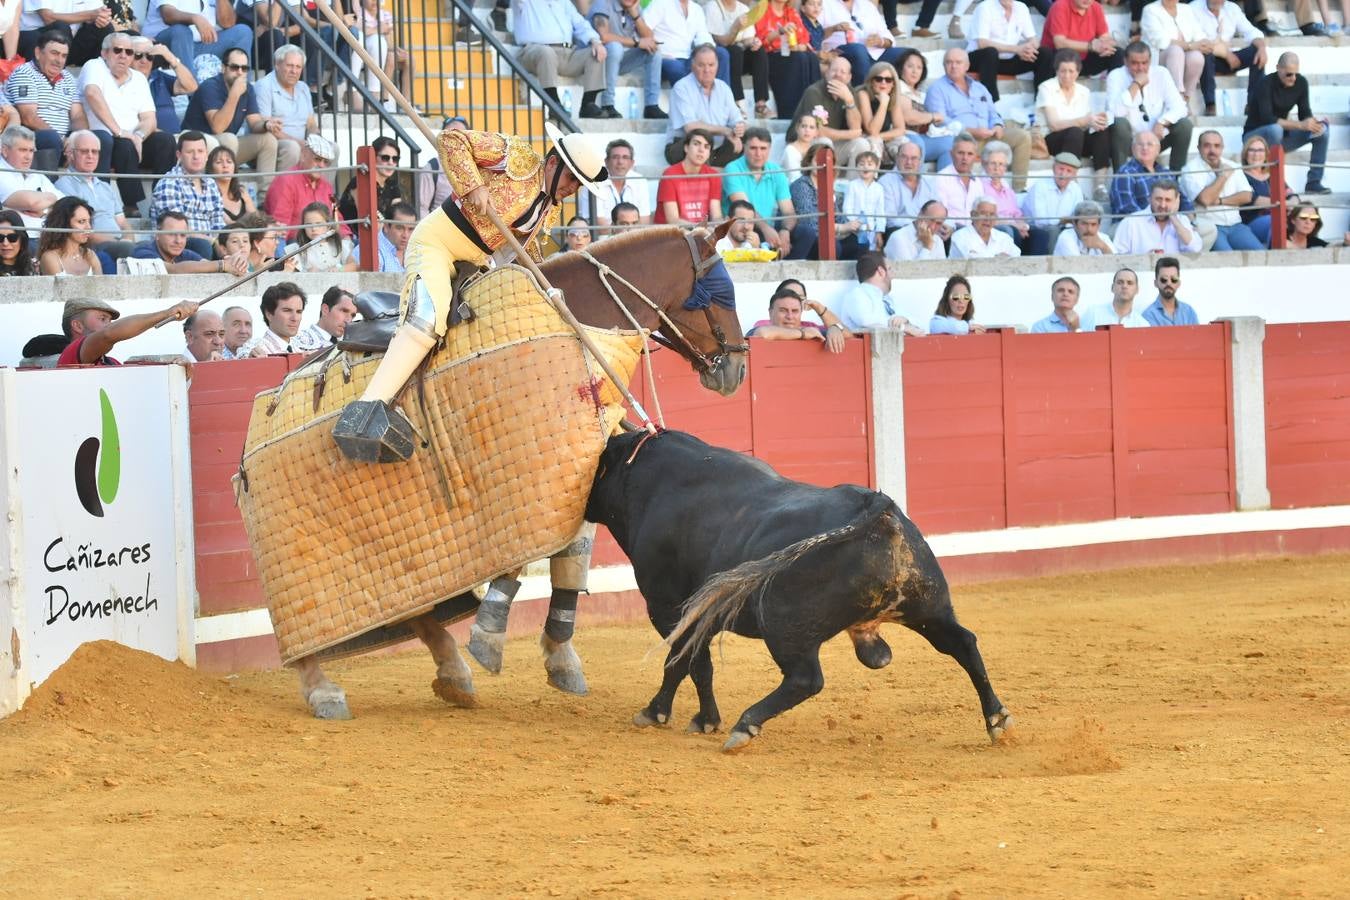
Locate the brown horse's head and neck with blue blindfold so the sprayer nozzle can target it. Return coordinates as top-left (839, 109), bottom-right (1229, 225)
top-left (544, 221), bottom-right (749, 395)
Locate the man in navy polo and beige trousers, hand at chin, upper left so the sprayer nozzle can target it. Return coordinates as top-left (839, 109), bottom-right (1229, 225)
top-left (182, 49), bottom-right (300, 188)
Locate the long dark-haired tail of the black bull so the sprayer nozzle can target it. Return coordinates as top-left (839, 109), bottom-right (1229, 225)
top-left (664, 493), bottom-right (892, 661)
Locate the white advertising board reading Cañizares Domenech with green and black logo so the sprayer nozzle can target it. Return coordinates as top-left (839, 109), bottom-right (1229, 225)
top-left (0, 366), bottom-right (194, 715)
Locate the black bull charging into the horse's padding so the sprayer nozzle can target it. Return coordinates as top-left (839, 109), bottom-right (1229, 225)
top-left (586, 432), bottom-right (1013, 750)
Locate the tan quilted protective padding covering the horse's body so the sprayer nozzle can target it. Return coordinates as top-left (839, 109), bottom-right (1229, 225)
top-left (236, 267), bottom-right (645, 663)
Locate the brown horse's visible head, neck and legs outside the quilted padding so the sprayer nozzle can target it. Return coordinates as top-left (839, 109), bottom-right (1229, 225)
top-left (294, 225), bottom-right (748, 719)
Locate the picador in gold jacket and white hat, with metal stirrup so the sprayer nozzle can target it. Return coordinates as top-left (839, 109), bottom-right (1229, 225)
top-left (333, 123), bottom-right (609, 463)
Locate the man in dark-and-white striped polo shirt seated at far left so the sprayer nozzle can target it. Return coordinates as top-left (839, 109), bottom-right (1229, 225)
top-left (4, 28), bottom-right (89, 171)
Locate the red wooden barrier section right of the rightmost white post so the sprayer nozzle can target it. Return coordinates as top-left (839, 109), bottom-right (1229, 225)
top-left (1264, 322), bottom-right (1350, 509)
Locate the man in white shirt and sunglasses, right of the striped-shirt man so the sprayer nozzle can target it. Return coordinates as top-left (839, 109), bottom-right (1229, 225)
top-left (80, 31), bottom-right (178, 208)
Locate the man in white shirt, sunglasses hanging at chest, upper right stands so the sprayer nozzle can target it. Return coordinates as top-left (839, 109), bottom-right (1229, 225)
top-left (1106, 40), bottom-right (1193, 171)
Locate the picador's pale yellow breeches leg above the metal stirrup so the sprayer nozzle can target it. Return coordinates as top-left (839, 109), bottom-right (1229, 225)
top-left (360, 209), bottom-right (487, 403)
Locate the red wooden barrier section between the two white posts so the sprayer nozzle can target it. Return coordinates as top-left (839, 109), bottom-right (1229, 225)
top-left (896, 324), bottom-right (1237, 533)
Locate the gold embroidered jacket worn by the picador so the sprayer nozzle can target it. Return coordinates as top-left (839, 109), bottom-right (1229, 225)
top-left (437, 130), bottom-right (562, 260)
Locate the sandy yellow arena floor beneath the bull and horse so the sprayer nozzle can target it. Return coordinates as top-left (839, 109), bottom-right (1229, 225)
top-left (0, 556), bottom-right (1350, 897)
